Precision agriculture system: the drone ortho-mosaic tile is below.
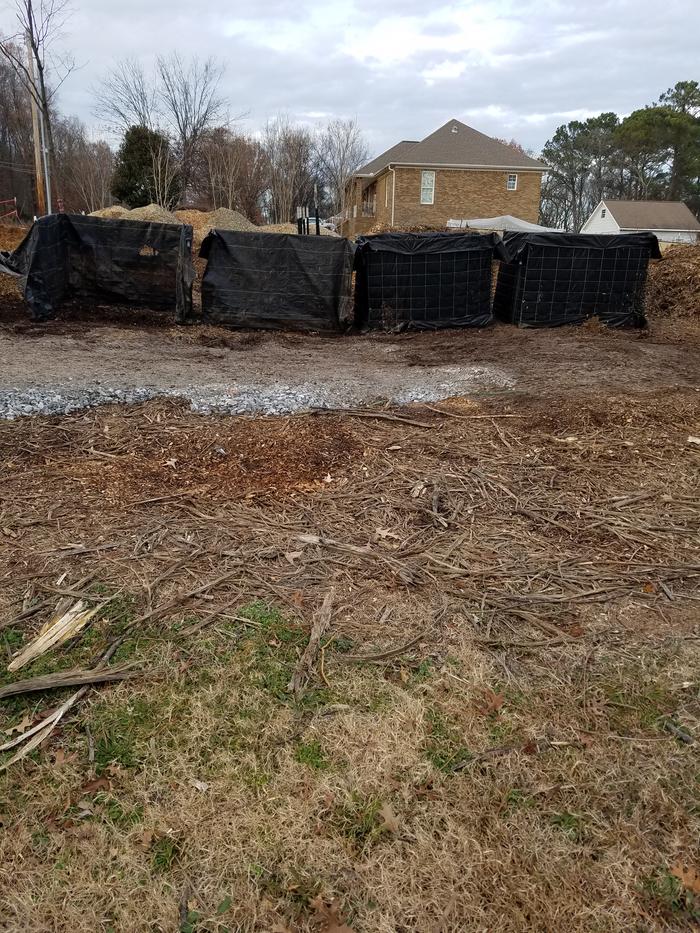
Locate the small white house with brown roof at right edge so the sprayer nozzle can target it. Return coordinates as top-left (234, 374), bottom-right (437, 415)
top-left (581, 200), bottom-right (700, 243)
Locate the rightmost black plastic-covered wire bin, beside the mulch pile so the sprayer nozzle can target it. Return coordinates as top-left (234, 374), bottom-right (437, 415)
top-left (494, 233), bottom-right (661, 327)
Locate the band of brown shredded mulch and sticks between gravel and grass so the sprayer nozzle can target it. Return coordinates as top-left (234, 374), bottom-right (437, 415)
top-left (0, 390), bottom-right (700, 631)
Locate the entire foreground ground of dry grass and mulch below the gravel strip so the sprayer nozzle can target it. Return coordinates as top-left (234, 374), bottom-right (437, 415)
top-left (0, 392), bottom-right (700, 933)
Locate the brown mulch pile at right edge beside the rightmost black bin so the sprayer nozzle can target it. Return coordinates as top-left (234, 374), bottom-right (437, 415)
top-left (647, 246), bottom-right (700, 319)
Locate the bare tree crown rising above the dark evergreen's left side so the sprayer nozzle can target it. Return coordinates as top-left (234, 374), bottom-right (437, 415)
top-left (94, 58), bottom-right (158, 132)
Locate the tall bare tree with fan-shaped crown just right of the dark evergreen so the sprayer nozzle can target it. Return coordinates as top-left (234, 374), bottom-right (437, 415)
top-left (158, 53), bottom-right (224, 197)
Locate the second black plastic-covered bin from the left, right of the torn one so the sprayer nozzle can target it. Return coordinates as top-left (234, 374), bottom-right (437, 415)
top-left (199, 230), bottom-right (353, 331)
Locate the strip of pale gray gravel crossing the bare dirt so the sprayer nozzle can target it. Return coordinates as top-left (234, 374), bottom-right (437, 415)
top-left (0, 365), bottom-right (515, 419)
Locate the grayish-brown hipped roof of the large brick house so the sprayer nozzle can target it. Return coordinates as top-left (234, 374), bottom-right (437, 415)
top-left (357, 120), bottom-right (547, 175)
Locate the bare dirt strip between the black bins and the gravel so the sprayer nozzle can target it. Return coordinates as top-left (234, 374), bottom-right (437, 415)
top-left (0, 321), bottom-right (700, 407)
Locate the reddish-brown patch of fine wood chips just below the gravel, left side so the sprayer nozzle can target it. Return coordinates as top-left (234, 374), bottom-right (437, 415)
top-left (0, 402), bottom-right (357, 507)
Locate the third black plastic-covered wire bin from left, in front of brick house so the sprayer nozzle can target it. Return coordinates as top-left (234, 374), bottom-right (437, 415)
top-left (355, 233), bottom-right (502, 330)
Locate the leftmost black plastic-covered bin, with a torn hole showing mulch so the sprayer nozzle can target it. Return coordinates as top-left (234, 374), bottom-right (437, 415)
top-left (0, 214), bottom-right (194, 322)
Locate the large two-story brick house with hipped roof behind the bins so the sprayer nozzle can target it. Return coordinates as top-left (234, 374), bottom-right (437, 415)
top-left (340, 120), bottom-right (547, 236)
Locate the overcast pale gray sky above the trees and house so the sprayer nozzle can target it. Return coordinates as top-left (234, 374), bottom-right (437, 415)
top-left (0, 0), bottom-right (700, 154)
